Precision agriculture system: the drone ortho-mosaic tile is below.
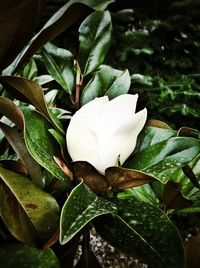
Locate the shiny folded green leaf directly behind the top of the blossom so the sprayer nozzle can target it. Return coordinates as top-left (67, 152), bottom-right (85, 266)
top-left (81, 65), bottom-right (130, 105)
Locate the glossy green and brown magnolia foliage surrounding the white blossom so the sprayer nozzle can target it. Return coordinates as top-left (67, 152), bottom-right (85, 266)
top-left (0, 0), bottom-right (200, 268)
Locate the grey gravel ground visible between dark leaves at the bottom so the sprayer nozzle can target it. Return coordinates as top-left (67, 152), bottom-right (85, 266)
top-left (74, 229), bottom-right (148, 268)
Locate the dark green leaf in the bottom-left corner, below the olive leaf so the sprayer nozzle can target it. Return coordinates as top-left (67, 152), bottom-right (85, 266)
top-left (0, 243), bottom-right (60, 268)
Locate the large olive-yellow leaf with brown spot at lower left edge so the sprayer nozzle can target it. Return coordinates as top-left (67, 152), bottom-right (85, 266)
top-left (0, 167), bottom-right (59, 244)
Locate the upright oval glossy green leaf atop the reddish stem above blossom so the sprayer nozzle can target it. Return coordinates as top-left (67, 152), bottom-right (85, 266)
top-left (79, 11), bottom-right (112, 76)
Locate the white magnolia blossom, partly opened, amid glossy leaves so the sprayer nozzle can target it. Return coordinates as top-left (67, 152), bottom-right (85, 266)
top-left (66, 94), bottom-right (147, 173)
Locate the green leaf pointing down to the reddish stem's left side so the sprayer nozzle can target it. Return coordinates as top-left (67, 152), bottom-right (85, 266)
top-left (41, 43), bottom-right (75, 94)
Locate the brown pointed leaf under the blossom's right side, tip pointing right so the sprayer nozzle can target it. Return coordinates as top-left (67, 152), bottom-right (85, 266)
top-left (105, 167), bottom-right (155, 190)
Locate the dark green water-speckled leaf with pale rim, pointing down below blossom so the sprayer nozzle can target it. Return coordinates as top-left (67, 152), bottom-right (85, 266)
top-left (60, 182), bottom-right (116, 245)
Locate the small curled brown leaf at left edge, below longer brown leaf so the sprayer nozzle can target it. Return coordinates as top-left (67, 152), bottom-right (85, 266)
top-left (0, 97), bottom-right (24, 130)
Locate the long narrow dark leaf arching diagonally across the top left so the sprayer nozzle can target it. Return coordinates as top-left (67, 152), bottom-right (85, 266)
top-left (4, 0), bottom-right (114, 75)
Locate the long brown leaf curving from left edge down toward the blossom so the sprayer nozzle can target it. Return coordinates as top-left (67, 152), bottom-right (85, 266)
top-left (0, 76), bottom-right (63, 132)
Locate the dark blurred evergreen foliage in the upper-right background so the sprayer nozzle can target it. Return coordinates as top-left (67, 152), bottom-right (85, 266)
top-left (107, 0), bottom-right (200, 128)
